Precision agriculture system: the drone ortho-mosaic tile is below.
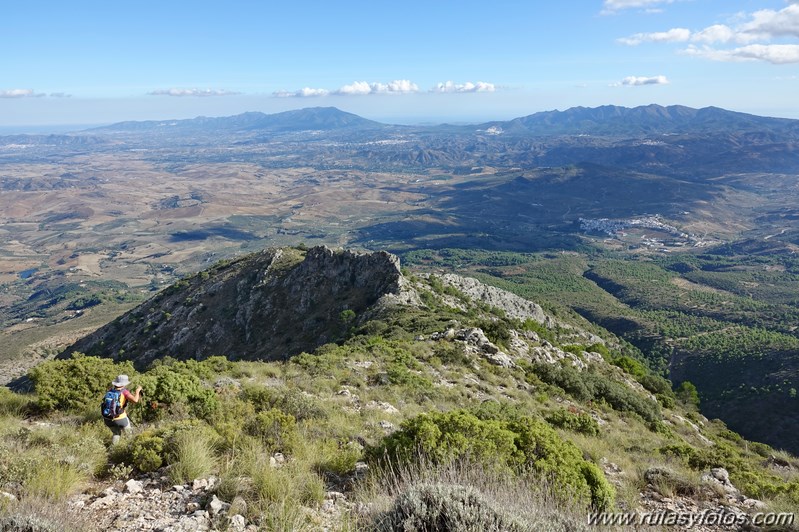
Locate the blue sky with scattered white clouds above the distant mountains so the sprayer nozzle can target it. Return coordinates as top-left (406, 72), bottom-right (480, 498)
top-left (0, 0), bottom-right (799, 132)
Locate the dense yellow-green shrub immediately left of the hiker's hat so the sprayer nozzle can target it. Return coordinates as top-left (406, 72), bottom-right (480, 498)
top-left (28, 353), bottom-right (135, 412)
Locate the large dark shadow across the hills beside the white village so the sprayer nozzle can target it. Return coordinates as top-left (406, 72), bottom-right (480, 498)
top-left (355, 164), bottom-right (722, 251)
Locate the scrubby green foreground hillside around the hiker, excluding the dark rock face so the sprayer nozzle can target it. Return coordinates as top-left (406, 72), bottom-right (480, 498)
top-left (0, 249), bottom-right (799, 530)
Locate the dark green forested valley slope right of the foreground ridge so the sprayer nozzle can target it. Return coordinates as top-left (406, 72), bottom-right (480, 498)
top-left (405, 250), bottom-right (799, 451)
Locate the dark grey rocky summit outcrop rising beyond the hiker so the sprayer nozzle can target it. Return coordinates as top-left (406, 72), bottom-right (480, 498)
top-left (64, 246), bottom-right (418, 367)
